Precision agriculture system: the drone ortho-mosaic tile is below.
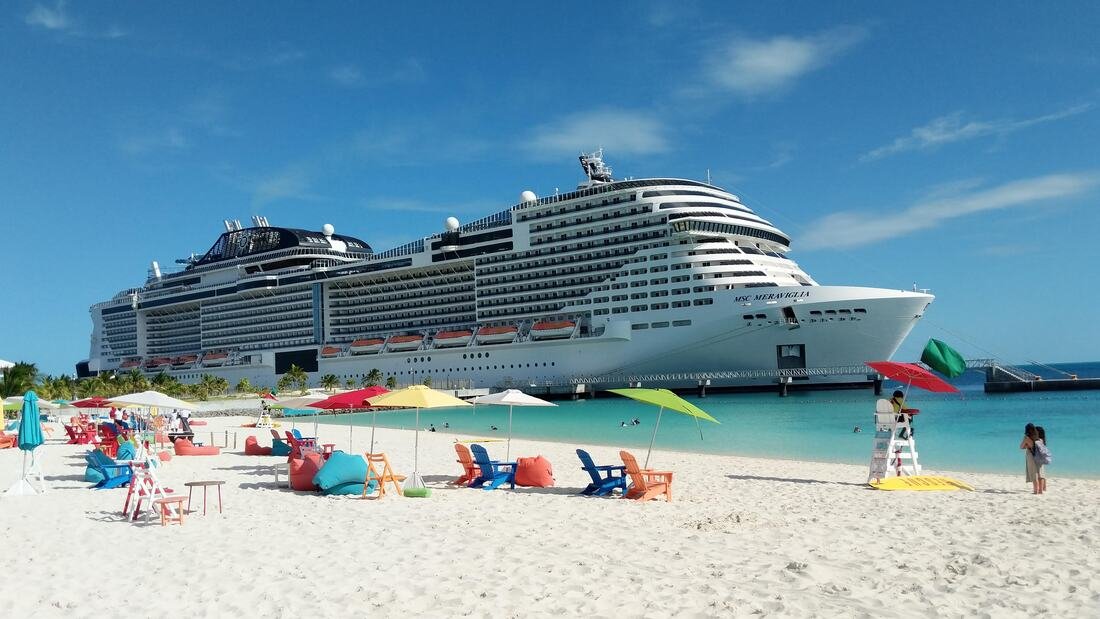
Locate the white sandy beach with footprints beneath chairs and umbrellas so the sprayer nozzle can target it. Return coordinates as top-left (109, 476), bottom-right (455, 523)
top-left (0, 418), bottom-right (1100, 617)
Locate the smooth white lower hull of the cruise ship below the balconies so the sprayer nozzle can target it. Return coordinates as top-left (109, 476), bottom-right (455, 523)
top-left (150, 286), bottom-right (933, 390)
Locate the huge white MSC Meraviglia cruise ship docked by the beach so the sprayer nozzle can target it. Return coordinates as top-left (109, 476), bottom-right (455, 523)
top-left (77, 152), bottom-right (933, 390)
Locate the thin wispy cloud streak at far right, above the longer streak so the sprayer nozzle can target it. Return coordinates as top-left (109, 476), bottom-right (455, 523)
top-left (859, 103), bottom-right (1092, 162)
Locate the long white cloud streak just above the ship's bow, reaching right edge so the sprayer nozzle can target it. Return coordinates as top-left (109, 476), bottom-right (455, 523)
top-left (799, 173), bottom-right (1100, 250)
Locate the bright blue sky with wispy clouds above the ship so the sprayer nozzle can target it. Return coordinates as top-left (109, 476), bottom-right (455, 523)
top-left (0, 2), bottom-right (1100, 374)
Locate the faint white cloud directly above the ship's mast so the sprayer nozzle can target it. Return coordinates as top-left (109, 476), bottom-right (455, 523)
top-left (520, 109), bottom-right (669, 158)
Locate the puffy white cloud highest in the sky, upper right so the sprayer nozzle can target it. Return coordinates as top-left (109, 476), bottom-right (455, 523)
top-left (705, 26), bottom-right (867, 97)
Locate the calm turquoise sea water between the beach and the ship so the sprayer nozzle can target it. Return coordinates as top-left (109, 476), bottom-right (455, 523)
top-left (321, 365), bottom-right (1100, 477)
